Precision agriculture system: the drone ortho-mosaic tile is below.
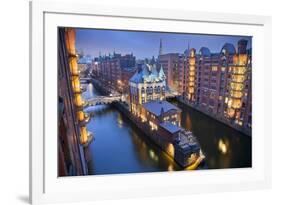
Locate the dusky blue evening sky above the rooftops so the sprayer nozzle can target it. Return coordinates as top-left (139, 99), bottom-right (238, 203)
top-left (76, 29), bottom-right (252, 59)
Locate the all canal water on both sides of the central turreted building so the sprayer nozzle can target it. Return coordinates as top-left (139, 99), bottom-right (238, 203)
top-left (83, 84), bottom-right (251, 175)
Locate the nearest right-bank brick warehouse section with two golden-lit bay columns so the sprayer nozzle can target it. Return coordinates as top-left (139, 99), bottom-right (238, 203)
top-left (185, 39), bottom-right (252, 131)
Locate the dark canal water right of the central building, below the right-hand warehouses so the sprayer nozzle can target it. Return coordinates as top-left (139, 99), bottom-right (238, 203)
top-left (172, 98), bottom-right (252, 169)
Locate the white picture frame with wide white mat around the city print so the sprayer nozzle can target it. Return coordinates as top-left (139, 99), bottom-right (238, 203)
top-left (30, 1), bottom-right (271, 204)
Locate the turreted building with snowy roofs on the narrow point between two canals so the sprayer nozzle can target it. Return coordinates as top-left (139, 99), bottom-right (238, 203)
top-left (127, 64), bottom-right (203, 167)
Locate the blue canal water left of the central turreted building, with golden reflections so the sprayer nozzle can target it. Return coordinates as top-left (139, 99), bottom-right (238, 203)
top-left (85, 83), bottom-right (181, 174)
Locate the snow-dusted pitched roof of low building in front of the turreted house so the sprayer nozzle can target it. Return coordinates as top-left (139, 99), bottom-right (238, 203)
top-left (143, 100), bottom-right (180, 116)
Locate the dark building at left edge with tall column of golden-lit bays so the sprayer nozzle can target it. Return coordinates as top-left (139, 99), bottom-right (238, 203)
top-left (58, 28), bottom-right (93, 176)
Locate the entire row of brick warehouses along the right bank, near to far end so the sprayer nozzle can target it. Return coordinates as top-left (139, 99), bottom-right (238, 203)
top-left (157, 39), bottom-right (252, 131)
